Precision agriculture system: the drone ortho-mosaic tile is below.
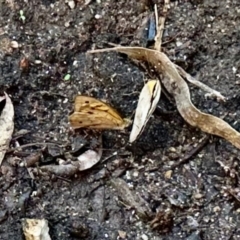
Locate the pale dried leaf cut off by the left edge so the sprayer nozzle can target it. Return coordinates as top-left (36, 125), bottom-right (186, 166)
top-left (0, 93), bottom-right (14, 165)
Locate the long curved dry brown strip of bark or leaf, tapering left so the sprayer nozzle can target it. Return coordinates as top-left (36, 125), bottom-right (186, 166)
top-left (89, 47), bottom-right (240, 149)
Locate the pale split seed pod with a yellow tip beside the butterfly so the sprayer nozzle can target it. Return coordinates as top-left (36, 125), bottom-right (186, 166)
top-left (129, 80), bottom-right (161, 143)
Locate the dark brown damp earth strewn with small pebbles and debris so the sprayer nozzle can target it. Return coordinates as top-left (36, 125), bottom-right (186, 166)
top-left (0, 0), bottom-right (240, 240)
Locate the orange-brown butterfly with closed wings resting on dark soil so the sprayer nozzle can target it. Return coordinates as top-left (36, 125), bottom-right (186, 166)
top-left (69, 95), bottom-right (131, 130)
